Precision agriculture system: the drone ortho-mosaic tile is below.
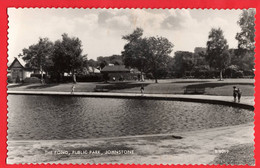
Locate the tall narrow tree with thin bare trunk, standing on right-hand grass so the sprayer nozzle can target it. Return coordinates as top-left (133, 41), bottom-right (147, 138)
top-left (206, 28), bottom-right (230, 80)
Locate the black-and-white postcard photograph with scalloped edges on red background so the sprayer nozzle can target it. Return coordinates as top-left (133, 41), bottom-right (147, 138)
top-left (6, 8), bottom-right (256, 165)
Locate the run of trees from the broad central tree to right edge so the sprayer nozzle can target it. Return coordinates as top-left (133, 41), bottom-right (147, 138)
top-left (122, 9), bottom-right (255, 82)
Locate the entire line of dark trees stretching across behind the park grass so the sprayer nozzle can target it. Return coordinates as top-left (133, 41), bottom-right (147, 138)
top-left (19, 9), bottom-right (255, 82)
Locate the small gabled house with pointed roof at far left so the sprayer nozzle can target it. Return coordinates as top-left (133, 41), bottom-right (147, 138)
top-left (7, 57), bottom-right (33, 82)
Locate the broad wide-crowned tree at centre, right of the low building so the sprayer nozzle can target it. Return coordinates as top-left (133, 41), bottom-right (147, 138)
top-left (122, 28), bottom-right (173, 83)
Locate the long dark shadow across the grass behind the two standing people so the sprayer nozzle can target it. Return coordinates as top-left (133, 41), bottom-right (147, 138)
top-left (186, 82), bottom-right (254, 88)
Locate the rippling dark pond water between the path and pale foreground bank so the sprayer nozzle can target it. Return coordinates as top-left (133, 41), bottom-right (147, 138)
top-left (8, 95), bottom-right (254, 140)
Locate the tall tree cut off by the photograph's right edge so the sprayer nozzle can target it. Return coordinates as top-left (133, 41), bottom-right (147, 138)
top-left (236, 9), bottom-right (256, 71)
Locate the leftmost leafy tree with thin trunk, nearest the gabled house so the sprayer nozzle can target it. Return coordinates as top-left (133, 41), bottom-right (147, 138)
top-left (22, 38), bottom-right (53, 83)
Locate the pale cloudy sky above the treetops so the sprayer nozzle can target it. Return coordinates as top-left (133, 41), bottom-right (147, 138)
top-left (8, 8), bottom-right (242, 62)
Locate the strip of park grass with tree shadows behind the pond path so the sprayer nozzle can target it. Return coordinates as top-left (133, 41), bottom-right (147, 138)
top-left (8, 79), bottom-right (254, 96)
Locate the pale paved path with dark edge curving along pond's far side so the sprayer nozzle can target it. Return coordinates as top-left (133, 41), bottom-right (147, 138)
top-left (7, 91), bottom-right (254, 109)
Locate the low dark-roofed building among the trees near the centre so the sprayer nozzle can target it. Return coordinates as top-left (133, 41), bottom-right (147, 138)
top-left (101, 64), bottom-right (140, 81)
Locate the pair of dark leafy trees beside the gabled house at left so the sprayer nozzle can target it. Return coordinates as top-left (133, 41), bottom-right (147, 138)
top-left (22, 34), bottom-right (87, 81)
